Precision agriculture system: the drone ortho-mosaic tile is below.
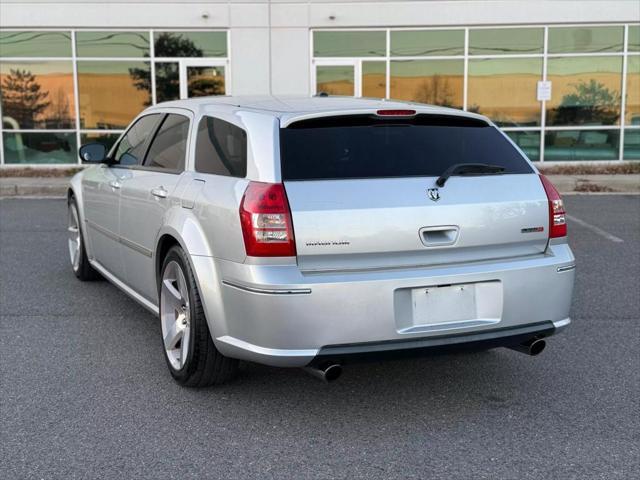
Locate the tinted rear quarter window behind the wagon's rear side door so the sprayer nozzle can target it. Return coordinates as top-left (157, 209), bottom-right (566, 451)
top-left (196, 117), bottom-right (247, 177)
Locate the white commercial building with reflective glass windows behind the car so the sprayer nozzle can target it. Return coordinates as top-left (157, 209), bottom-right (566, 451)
top-left (0, 0), bottom-right (640, 165)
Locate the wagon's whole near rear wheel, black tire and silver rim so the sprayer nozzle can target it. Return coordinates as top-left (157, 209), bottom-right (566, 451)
top-left (158, 246), bottom-right (238, 387)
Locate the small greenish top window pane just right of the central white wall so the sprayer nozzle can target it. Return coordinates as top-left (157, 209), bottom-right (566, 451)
top-left (313, 31), bottom-right (387, 57)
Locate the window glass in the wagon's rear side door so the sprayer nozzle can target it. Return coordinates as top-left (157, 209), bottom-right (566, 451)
top-left (144, 113), bottom-right (189, 172)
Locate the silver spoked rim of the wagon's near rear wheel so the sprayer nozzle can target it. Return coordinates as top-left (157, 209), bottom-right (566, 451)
top-left (160, 261), bottom-right (191, 370)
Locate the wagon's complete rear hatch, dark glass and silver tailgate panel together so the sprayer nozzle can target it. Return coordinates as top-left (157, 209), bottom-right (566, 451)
top-left (280, 111), bottom-right (549, 271)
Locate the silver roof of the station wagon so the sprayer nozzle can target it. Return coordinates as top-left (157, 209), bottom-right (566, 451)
top-left (151, 95), bottom-right (488, 124)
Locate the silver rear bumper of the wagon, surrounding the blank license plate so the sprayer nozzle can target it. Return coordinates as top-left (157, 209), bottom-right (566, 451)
top-left (192, 244), bottom-right (575, 366)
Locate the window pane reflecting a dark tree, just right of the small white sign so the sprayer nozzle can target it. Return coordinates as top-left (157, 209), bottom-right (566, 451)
top-left (546, 57), bottom-right (622, 125)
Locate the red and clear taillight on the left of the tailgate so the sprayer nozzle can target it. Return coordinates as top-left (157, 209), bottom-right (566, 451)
top-left (240, 182), bottom-right (296, 257)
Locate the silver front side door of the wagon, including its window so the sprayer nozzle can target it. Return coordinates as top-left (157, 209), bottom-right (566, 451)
top-left (83, 114), bottom-right (161, 279)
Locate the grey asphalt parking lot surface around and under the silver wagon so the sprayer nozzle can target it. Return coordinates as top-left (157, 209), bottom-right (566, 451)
top-left (0, 195), bottom-right (640, 479)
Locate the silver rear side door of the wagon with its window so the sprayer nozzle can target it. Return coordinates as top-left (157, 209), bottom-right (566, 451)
top-left (120, 112), bottom-right (191, 303)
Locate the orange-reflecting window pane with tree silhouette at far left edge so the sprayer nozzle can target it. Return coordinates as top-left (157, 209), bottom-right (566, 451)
top-left (0, 61), bottom-right (75, 130)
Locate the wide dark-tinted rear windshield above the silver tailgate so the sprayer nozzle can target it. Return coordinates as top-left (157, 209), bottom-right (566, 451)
top-left (280, 115), bottom-right (533, 180)
